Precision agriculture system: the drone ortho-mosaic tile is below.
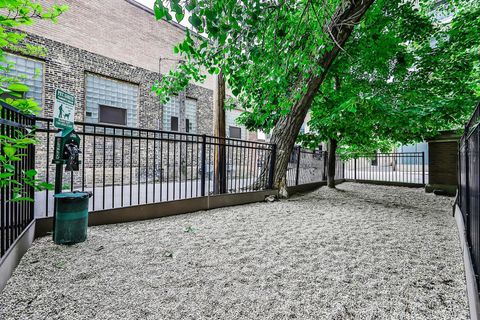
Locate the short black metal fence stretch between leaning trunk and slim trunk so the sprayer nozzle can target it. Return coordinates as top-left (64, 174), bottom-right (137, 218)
top-left (287, 146), bottom-right (343, 187)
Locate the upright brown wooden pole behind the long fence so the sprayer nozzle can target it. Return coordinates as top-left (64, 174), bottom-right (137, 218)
top-left (213, 71), bottom-right (227, 194)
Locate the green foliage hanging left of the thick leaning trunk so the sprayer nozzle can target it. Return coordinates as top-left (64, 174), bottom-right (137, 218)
top-left (155, 0), bottom-right (348, 112)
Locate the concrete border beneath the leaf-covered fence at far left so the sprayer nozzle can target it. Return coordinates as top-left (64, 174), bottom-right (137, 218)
top-left (0, 220), bottom-right (35, 292)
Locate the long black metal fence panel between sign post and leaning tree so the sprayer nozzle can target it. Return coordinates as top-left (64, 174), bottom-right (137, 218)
top-left (35, 118), bottom-right (275, 217)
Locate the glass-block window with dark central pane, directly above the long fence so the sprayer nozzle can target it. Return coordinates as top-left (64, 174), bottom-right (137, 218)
top-left (85, 73), bottom-right (138, 127)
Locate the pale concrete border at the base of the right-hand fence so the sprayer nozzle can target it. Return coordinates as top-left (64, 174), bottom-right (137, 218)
top-left (454, 204), bottom-right (480, 320)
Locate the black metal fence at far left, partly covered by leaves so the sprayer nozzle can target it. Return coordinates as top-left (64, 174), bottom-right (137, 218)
top-left (0, 101), bottom-right (35, 258)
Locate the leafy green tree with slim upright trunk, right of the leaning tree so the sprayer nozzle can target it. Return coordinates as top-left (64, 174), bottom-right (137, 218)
top-left (299, 2), bottom-right (480, 187)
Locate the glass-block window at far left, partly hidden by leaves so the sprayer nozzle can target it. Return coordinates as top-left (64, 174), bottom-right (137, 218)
top-left (0, 54), bottom-right (43, 106)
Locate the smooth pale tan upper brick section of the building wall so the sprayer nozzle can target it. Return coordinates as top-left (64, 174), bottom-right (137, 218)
top-left (17, 0), bottom-right (215, 90)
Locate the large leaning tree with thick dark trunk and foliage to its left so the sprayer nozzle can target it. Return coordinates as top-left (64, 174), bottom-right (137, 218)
top-left (154, 0), bottom-right (381, 194)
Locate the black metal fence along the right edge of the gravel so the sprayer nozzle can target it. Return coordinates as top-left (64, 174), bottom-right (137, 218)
top-left (456, 105), bottom-right (480, 292)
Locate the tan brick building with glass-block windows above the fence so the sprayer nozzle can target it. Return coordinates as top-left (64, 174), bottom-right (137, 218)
top-left (8, 0), bottom-right (257, 139)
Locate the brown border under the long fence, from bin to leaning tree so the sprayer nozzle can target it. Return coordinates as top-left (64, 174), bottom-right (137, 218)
top-left (35, 190), bottom-right (278, 238)
